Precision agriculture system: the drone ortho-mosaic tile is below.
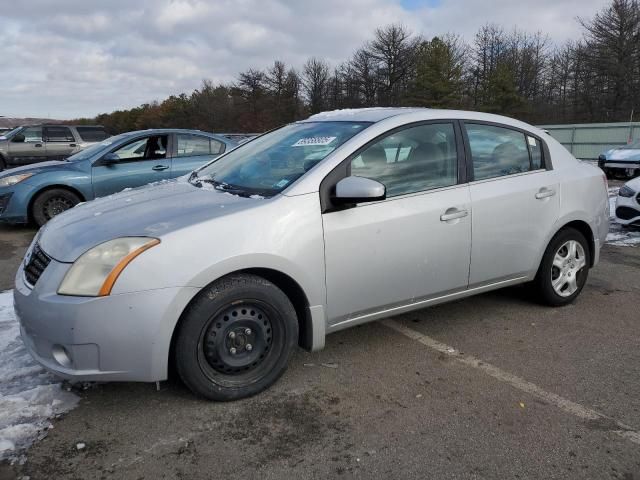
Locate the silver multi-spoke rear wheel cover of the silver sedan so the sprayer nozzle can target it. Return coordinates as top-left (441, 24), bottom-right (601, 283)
top-left (551, 240), bottom-right (587, 297)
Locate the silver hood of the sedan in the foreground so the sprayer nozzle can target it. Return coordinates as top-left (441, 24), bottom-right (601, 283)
top-left (38, 178), bottom-right (266, 262)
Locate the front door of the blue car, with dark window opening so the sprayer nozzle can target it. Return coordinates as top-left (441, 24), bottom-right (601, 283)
top-left (91, 135), bottom-right (171, 197)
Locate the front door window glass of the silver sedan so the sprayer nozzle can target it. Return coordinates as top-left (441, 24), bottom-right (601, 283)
top-left (351, 123), bottom-right (458, 197)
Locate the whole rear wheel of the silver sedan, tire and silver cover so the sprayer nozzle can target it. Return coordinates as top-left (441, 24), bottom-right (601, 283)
top-left (534, 228), bottom-right (591, 307)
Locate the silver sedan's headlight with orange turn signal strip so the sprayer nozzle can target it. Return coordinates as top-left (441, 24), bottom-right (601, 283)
top-left (58, 237), bottom-right (160, 297)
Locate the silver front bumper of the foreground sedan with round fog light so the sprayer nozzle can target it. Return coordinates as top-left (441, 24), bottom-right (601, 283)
top-left (14, 251), bottom-right (198, 382)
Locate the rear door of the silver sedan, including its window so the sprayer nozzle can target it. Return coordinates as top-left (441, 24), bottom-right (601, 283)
top-left (465, 122), bottom-right (560, 288)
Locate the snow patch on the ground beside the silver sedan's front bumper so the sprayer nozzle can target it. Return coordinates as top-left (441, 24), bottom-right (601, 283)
top-left (0, 291), bottom-right (80, 461)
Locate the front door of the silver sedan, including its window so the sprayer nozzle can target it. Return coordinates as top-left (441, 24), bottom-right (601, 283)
top-left (322, 123), bottom-right (471, 325)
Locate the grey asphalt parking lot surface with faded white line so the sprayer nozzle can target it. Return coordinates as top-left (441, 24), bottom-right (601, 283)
top-left (0, 218), bottom-right (640, 480)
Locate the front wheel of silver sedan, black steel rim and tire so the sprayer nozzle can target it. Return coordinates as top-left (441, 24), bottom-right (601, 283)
top-left (175, 274), bottom-right (298, 401)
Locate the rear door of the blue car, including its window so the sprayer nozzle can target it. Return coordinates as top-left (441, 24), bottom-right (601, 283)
top-left (171, 133), bottom-right (225, 177)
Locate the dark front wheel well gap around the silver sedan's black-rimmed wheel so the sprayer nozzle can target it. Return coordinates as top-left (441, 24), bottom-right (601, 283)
top-left (169, 268), bottom-right (313, 376)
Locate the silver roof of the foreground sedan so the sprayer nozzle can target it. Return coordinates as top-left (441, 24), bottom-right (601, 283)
top-left (302, 107), bottom-right (542, 132)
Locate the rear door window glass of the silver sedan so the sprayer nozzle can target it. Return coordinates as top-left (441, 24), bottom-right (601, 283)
top-left (465, 123), bottom-right (541, 180)
